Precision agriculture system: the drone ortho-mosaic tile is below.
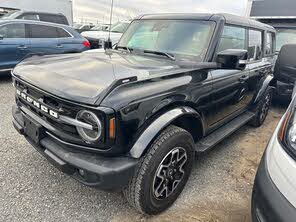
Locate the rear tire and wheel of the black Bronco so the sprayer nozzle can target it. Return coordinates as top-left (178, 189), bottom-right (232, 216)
top-left (250, 88), bottom-right (273, 127)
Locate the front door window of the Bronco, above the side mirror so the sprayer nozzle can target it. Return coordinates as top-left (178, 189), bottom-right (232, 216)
top-left (218, 25), bottom-right (246, 52)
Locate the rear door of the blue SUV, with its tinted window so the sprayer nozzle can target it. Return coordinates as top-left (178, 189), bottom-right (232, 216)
top-left (28, 24), bottom-right (60, 55)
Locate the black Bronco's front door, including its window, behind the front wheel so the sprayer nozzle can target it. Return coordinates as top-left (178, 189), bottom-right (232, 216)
top-left (210, 25), bottom-right (250, 128)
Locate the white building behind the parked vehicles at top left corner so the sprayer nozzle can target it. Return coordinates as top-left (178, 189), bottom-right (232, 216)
top-left (0, 0), bottom-right (73, 25)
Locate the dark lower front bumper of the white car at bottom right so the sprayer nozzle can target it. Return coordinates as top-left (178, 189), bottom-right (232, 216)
top-left (252, 155), bottom-right (296, 222)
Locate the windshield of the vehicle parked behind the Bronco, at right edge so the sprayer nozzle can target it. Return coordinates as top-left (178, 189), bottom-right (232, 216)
top-left (276, 28), bottom-right (296, 51)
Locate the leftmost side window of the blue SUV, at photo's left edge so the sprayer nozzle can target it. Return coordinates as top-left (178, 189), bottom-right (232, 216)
top-left (0, 24), bottom-right (26, 38)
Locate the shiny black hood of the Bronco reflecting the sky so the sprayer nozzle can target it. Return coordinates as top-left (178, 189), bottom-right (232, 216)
top-left (13, 52), bottom-right (188, 105)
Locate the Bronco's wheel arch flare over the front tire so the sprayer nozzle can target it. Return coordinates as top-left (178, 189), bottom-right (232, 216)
top-left (129, 106), bottom-right (205, 158)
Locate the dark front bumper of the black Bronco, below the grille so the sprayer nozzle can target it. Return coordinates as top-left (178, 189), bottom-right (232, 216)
top-left (12, 106), bottom-right (137, 191)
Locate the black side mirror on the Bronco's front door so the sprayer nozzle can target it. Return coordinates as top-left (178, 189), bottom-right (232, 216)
top-left (217, 49), bottom-right (248, 70)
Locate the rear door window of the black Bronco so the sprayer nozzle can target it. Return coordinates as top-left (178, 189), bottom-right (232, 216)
top-left (248, 29), bottom-right (263, 61)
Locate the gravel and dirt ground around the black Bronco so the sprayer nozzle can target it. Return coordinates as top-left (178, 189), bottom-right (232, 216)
top-left (0, 77), bottom-right (286, 222)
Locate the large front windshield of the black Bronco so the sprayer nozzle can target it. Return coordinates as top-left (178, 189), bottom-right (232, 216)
top-left (118, 20), bottom-right (215, 61)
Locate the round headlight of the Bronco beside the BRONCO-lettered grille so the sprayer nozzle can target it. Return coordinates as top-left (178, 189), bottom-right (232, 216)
top-left (76, 110), bottom-right (102, 143)
